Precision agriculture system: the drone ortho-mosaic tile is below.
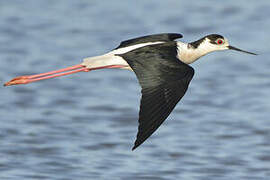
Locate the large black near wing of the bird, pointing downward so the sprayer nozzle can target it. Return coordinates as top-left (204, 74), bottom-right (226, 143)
top-left (120, 42), bottom-right (194, 150)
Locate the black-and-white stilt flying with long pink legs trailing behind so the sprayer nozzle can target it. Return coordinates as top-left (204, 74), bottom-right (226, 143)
top-left (4, 33), bottom-right (256, 150)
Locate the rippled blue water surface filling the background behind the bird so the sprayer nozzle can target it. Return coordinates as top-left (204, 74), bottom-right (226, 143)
top-left (0, 0), bottom-right (270, 180)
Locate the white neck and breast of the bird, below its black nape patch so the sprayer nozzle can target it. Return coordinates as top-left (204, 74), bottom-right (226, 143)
top-left (177, 41), bottom-right (218, 64)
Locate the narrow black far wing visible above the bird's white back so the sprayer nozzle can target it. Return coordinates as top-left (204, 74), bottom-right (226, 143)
top-left (115, 33), bottom-right (183, 49)
